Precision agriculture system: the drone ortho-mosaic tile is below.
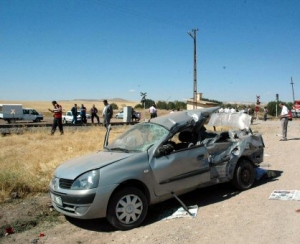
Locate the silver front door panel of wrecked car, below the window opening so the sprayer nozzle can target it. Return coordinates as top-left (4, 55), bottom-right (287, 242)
top-left (150, 145), bottom-right (210, 196)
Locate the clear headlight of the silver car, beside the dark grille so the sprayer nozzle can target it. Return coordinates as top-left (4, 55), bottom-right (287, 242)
top-left (71, 170), bottom-right (99, 190)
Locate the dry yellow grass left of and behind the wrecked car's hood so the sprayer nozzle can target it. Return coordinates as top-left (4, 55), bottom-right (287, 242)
top-left (0, 126), bottom-right (128, 202)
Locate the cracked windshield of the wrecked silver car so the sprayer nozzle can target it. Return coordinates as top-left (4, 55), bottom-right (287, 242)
top-left (106, 122), bottom-right (169, 152)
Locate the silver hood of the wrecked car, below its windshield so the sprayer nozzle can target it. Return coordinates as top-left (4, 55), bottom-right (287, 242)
top-left (54, 151), bottom-right (133, 179)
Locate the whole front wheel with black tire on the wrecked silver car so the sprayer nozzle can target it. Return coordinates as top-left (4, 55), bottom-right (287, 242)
top-left (106, 186), bottom-right (148, 230)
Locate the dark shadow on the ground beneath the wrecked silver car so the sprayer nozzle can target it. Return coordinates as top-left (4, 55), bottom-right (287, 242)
top-left (66, 170), bottom-right (283, 232)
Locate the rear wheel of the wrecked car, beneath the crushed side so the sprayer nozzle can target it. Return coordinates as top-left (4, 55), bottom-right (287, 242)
top-left (232, 159), bottom-right (255, 191)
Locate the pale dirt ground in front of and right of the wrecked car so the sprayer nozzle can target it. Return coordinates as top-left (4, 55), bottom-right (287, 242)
top-left (0, 120), bottom-right (300, 244)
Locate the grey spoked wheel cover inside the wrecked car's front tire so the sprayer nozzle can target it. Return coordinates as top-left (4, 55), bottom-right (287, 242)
top-left (116, 194), bottom-right (143, 224)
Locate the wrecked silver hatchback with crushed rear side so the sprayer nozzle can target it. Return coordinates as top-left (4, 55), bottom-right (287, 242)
top-left (50, 107), bottom-right (264, 230)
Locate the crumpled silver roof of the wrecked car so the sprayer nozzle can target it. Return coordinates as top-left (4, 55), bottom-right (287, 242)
top-left (150, 107), bottom-right (219, 131)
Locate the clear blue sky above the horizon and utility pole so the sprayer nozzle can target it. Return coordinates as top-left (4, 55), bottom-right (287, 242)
top-left (0, 0), bottom-right (300, 102)
